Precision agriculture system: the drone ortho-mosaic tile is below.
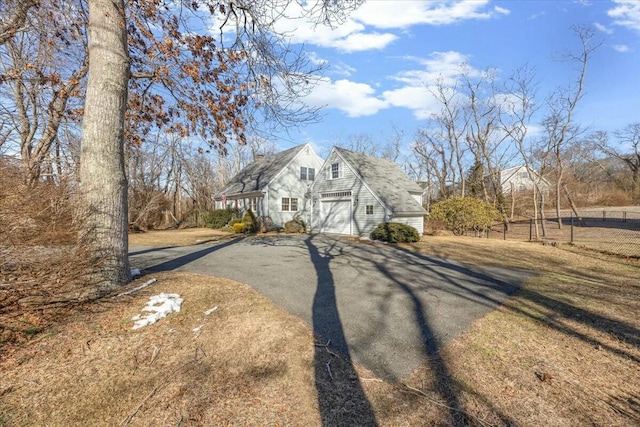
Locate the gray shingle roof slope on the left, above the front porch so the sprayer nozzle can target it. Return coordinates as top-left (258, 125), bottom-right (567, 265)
top-left (214, 144), bottom-right (306, 199)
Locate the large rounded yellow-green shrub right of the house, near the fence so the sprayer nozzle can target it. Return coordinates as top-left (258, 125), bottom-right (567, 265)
top-left (429, 197), bottom-right (500, 236)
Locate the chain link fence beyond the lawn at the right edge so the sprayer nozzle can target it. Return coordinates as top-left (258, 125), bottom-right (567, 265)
top-left (487, 207), bottom-right (640, 258)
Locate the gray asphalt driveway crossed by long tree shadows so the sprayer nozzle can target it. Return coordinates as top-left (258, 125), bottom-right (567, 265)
top-left (130, 235), bottom-right (533, 381)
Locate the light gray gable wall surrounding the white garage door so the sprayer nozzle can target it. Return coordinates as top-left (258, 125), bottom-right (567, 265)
top-left (310, 152), bottom-right (386, 235)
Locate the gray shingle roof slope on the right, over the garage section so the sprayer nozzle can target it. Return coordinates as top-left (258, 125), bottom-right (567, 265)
top-left (336, 147), bottom-right (427, 214)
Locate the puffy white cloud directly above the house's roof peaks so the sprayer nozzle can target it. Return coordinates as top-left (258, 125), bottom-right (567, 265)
top-left (305, 79), bottom-right (388, 117)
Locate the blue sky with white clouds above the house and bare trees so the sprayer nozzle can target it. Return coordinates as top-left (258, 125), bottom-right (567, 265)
top-left (268, 0), bottom-right (640, 155)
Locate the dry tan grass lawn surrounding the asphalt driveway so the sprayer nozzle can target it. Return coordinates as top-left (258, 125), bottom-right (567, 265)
top-left (0, 230), bottom-right (640, 426)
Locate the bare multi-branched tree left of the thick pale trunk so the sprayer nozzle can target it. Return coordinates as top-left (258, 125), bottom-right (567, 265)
top-left (0, 3), bottom-right (88, 185)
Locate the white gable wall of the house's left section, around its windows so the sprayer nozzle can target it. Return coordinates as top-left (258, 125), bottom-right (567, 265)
top-left (264, 146), bottom-right (322, 227)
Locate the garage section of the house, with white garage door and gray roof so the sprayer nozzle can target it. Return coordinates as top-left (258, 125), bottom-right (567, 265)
top-left (310, 147), bottom-right (427, 235)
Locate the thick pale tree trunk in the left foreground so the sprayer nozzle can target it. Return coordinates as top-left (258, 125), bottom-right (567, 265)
top-left (80, 0), bottom-right (131, 297)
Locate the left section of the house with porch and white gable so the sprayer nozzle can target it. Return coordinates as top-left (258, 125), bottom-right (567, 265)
top-left (214, 144), bottom-right (322, 226)
